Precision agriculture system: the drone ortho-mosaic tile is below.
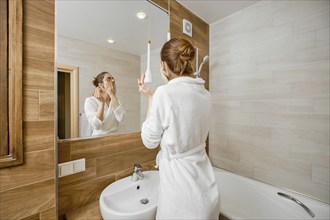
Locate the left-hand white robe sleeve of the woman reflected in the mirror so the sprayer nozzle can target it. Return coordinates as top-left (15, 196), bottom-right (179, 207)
top-left (84, 97), bottom-right (103, 130)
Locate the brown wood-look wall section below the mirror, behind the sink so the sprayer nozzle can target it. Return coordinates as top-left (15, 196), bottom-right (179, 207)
top-left (58, 132), bottom-right (159, 216)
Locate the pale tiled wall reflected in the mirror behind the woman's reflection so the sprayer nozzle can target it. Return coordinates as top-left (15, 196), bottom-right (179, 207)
top-left (57, 35), bottom-right (140, 132)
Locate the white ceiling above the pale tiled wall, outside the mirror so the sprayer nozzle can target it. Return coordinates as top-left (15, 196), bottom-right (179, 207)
top-left (177, 0), bottom-right (258, 24)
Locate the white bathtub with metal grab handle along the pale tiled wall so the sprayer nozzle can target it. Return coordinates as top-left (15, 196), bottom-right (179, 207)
top-left (214, 168), bottom-right (330, 219)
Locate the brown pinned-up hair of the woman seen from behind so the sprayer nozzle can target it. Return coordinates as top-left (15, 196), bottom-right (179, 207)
top-left (160, 38), bottom-right (195, 76)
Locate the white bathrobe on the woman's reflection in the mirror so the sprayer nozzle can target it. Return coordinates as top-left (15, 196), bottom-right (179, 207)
top-left (84, 96), bottom-right (126, 136)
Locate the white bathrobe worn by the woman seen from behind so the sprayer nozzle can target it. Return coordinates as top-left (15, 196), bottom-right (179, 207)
top-left (141, 77), bottom-right (220, 219)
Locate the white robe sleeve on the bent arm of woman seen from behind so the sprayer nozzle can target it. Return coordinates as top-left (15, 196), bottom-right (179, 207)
top-left (141, 87), bottom-right (172, 149)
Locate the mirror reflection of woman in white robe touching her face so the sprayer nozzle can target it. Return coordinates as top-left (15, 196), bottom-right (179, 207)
top-left (84, 72), bottom-right (126, 135)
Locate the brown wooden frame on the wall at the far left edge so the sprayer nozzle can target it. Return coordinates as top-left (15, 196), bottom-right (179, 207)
top-left (0, 0), bottom-right (24, 168)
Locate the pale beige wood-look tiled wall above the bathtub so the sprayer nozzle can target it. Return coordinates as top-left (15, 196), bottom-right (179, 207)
top-left (209, 1), bottom-right (329, 203)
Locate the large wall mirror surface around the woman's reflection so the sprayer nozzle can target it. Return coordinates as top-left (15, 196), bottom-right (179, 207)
top-left (55, 0), bottom-right (169, 139)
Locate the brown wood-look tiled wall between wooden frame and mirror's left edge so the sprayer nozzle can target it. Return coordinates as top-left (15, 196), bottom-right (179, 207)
top-left (0, 0), bottom-right (56, 220)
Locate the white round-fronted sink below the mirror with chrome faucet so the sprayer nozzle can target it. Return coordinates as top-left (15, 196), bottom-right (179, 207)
top-left (99, 171), bottom-right (159, 219)
